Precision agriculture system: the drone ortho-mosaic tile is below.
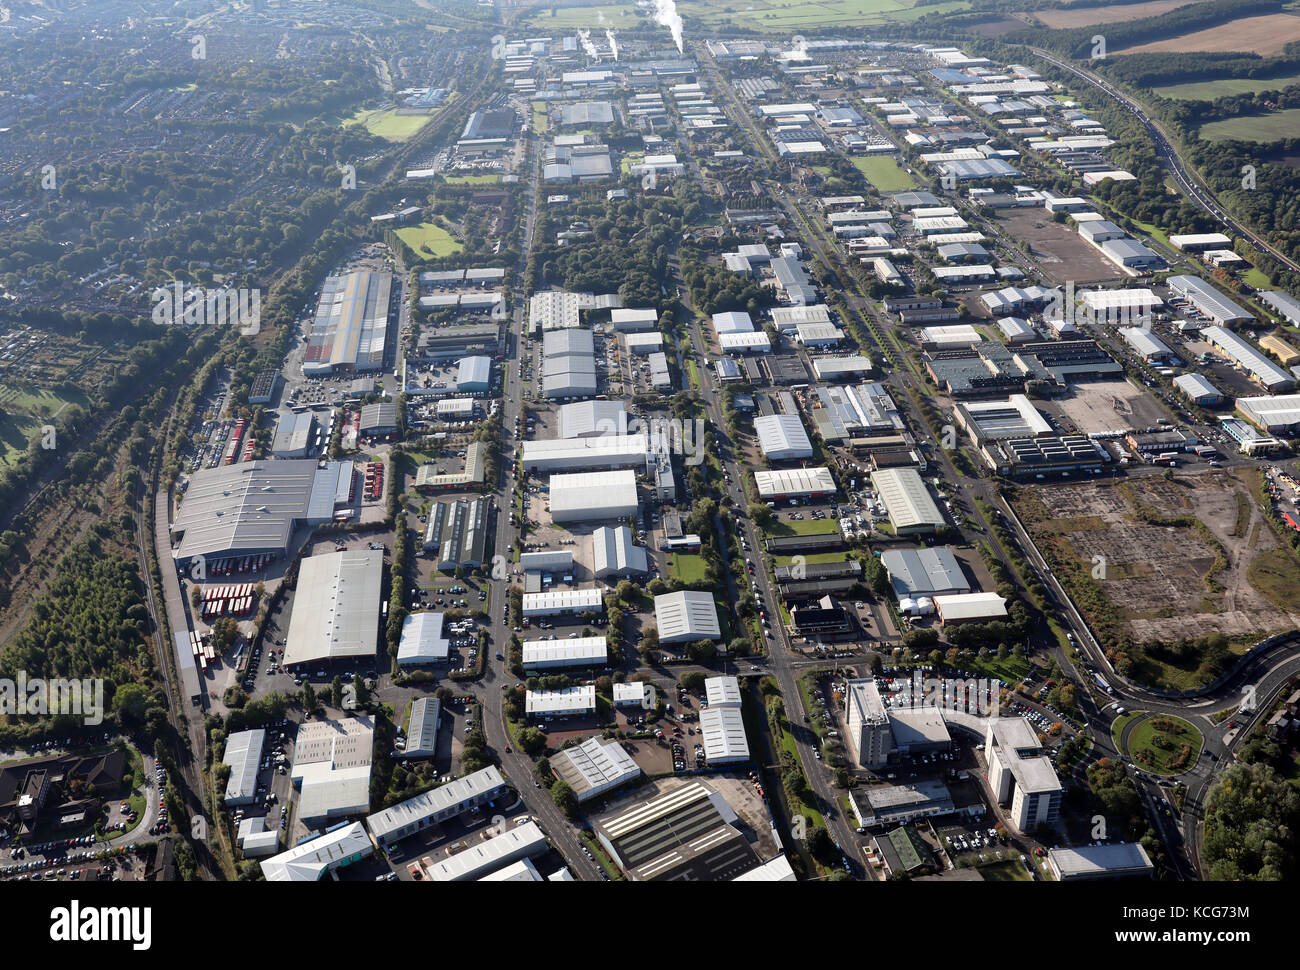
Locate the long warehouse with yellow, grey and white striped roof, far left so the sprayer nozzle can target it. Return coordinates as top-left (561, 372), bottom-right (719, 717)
top-left (303, 272), bottom-right (393, 377)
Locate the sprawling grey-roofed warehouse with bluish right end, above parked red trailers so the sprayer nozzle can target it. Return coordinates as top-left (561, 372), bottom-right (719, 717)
top-left (172, 458), bottom-right (352, 563)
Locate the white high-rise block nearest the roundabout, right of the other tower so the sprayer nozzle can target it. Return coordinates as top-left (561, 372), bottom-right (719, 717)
top-left (984, 718), bottom-right (1063, 832)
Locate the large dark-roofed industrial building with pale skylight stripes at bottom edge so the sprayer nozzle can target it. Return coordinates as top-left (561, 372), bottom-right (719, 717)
top-left (593, 781), bottom-right (759, 882)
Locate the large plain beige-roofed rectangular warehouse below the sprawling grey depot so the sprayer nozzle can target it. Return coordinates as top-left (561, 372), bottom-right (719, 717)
top-left (283, 550), bottom-right (384, 667)
